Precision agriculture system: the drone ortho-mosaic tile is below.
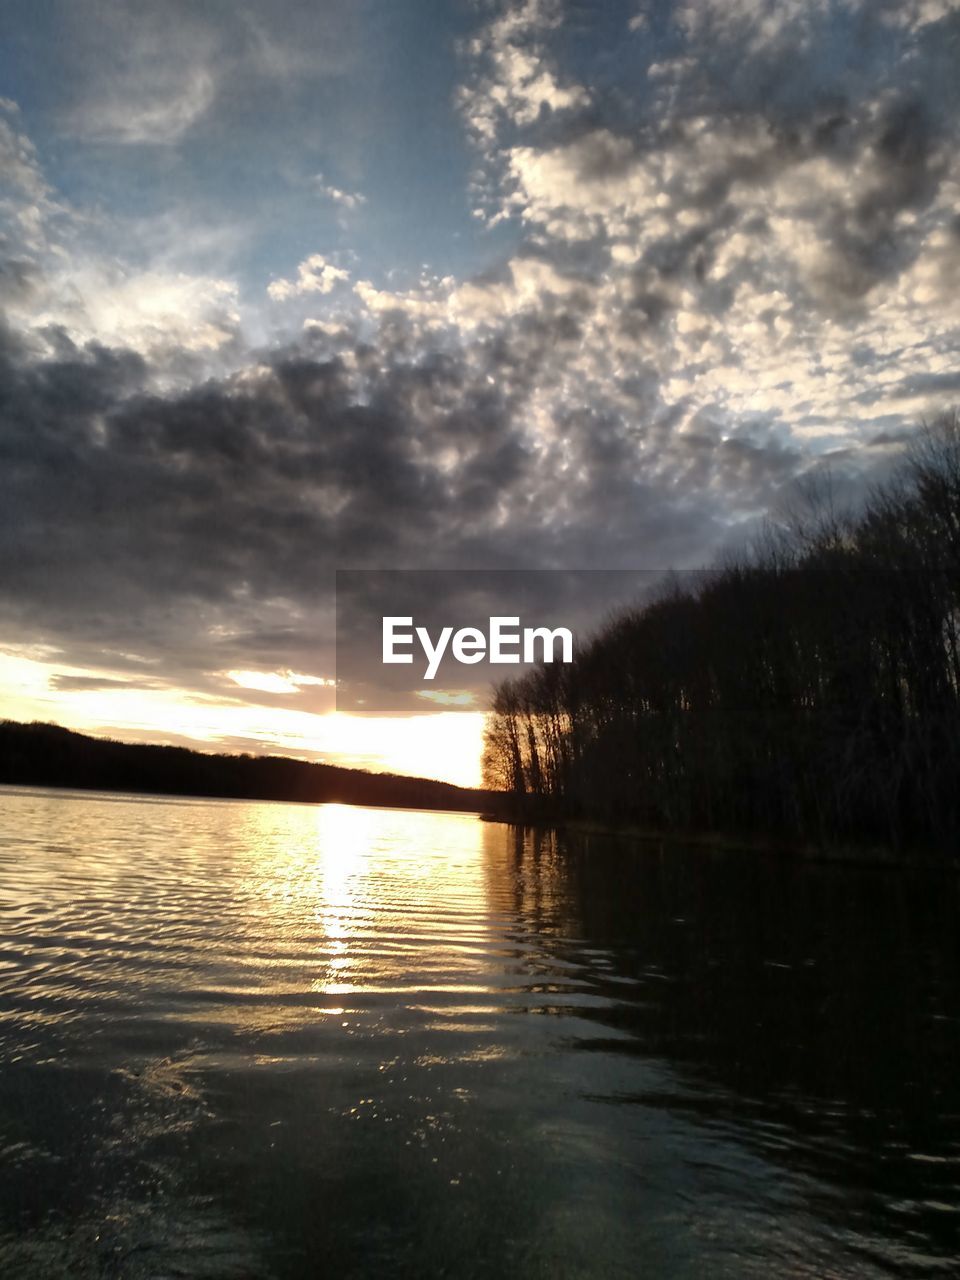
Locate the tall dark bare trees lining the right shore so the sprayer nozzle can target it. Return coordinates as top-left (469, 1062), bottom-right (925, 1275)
top-left (484, 412), bottom-right (960, 852)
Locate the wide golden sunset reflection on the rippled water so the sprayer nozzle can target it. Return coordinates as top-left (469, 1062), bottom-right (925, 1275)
top-left (0, 795), bottom-right (575, 1062)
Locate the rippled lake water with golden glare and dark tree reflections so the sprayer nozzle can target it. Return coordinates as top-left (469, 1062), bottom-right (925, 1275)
top-left (0, 790), bottom-right (960, 1280)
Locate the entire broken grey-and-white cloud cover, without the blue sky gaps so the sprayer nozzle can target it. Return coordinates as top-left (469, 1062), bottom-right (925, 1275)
top-left (0, 0), bottom-right (960, 727)
